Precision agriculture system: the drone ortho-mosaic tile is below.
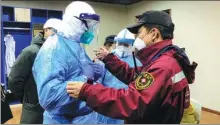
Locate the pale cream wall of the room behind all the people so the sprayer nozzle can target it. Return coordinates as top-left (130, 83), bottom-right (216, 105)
top-left (1, 1), bottom-right (220, 111)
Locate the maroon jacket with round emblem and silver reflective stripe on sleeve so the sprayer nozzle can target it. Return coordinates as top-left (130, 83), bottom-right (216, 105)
top-left (79, 40), bottom-right (196, 124)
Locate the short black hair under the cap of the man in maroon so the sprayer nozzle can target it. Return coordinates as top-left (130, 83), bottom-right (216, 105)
top-left (144, 24), bottom-right (174, 40)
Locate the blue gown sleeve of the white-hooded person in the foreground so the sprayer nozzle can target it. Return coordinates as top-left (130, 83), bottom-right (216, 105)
top-left (32, 50), bottom-right (75, 111)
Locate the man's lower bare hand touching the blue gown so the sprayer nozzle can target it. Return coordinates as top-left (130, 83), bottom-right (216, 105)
top-left (66, 81), bottom-right (84, 98)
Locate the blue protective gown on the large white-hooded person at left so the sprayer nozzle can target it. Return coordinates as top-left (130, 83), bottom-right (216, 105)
top-left (32, 34), bottom-right (97, 124)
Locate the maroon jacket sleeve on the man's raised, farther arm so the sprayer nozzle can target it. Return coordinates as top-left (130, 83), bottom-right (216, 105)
top-left (102, 54), bottom-right (142, 85)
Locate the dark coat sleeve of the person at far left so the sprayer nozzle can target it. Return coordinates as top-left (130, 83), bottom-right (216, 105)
top-left (8, 50), bottom-right (36, 98)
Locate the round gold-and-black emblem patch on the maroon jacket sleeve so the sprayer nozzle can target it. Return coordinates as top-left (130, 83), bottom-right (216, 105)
top-left (135, 72), bottom-right (154, 90)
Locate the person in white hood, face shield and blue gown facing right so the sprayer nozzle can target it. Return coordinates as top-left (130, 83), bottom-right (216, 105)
top-left (32, 1), bottom-right (103, 124)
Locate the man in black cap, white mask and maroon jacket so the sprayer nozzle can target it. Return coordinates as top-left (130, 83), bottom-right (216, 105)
top-left (67, 11), bottom-right (196, 124)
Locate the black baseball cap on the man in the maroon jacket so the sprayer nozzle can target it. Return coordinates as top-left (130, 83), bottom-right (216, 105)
top-left (127, 10), bottom-right (174, 34)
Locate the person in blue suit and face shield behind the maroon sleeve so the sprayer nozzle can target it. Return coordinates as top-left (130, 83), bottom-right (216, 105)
top-left (97, 29), bottom-right (142, 124)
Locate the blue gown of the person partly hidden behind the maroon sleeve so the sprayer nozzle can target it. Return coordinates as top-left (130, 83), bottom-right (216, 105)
top-left (97, 53), bottom-right (142, 124)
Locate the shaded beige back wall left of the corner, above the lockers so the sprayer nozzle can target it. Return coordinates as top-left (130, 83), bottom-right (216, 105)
top-left (2, 1), bottom-right (128, 58)
